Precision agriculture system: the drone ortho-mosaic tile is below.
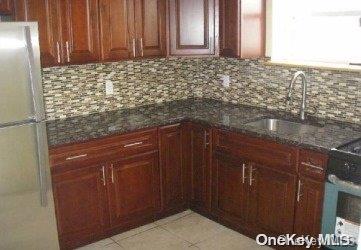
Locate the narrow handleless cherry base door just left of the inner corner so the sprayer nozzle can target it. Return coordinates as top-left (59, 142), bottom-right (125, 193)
top-left (159, 124), bottom-right (188, 213)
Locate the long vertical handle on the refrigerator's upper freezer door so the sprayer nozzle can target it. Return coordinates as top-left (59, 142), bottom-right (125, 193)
top-left (24, 26), bottom-right (45, 122)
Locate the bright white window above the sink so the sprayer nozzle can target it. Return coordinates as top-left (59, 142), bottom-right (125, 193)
top-left (266, 0), bottom-right (361, 66)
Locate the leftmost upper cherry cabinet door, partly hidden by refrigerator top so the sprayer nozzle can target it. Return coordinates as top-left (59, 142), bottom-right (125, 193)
top-left (14, 0), bottom-right (63, 67)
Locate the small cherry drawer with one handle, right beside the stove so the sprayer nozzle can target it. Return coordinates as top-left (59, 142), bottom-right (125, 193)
top-left (299, 149), bottom-right (328, 180)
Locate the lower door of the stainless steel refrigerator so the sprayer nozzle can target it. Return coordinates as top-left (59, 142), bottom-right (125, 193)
top-left (0, 123), bottom-right (59, 250)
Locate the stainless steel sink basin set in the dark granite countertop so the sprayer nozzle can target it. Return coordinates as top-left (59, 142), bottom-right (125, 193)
top-left (246, 118), bottom-right (320, 134)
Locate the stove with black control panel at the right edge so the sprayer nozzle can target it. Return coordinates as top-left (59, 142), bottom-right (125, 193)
top-left (322, 139), bottom-right (361, 249)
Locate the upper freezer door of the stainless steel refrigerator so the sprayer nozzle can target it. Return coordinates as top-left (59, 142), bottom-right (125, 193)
top-left (0, 23), bottom-right (44, 127)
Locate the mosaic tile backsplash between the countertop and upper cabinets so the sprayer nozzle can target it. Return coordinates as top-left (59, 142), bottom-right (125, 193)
top-left (43, 57), bottom-right (361, 124)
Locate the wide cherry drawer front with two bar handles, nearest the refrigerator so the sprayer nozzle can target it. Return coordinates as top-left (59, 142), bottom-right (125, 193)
top-left (50, 129), bottom-right (158, 166)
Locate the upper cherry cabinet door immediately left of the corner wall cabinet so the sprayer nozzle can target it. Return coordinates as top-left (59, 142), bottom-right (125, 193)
top-left (134, 0), bottom-right (166, 57)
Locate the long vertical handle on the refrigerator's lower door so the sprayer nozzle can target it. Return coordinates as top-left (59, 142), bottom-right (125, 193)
top-left (36, 122), bottom-right (50, 207)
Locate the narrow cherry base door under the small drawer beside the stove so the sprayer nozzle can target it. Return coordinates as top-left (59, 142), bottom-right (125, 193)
top-left (294, 177), bottom-right (325, 237)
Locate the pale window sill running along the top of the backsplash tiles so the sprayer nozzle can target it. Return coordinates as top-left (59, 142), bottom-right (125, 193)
top-left (264, 60), bottom-right (361, 72)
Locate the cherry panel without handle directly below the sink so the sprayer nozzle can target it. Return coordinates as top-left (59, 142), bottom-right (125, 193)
top-left (213, 130), bottom-right (298, 173)
